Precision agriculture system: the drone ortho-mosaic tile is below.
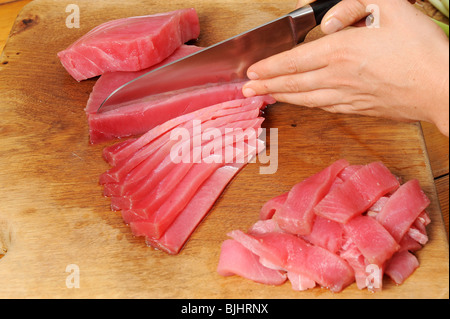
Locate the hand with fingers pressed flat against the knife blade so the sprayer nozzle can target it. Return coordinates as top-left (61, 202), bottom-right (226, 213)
top-left (243, 0), bottom-right (449, 136)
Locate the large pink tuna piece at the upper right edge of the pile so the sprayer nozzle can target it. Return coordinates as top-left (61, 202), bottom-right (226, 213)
top-left (377, 179), bottom-right (430, 242)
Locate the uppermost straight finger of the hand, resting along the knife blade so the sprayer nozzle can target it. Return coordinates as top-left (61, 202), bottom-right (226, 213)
top-left (247, 39), bottom-right (331, 80)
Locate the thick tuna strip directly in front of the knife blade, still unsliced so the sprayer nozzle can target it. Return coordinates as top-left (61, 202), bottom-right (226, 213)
top-left (88, 82), bottom-right (250, 144)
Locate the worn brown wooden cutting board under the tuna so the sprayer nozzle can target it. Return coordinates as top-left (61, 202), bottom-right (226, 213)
top-left (0, 0), bottom-right (449, 298)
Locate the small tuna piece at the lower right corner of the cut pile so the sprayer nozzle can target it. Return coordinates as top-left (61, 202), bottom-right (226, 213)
top-left (385, 250), bottom-right (419, 285)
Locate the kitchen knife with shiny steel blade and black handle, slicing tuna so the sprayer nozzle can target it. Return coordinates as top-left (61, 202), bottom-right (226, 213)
top-left (97, 0), bottom-right (341, 113)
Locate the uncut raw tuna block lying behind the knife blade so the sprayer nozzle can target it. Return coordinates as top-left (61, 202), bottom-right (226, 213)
top-left (58, 9), bottom-right (200, 81)
